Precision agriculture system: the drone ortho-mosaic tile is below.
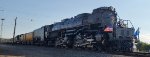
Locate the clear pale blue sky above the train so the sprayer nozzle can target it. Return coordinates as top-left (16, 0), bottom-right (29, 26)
top-left (0, 0), bottom-right (150, 43)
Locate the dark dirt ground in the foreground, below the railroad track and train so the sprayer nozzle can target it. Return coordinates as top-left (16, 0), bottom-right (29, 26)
top-left (0, 44), bottom-right (132, 57)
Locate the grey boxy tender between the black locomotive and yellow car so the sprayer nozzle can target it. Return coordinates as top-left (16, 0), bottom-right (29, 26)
top-left (33, 25), bottom-right (55, 46)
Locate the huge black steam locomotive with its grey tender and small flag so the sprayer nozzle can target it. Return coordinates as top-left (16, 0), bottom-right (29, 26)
top-left (12, 7), bottom-right (137, 52)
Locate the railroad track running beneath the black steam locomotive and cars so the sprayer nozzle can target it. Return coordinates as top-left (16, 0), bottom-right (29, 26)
top-left (2, 44), bottom-right (150, 57)
